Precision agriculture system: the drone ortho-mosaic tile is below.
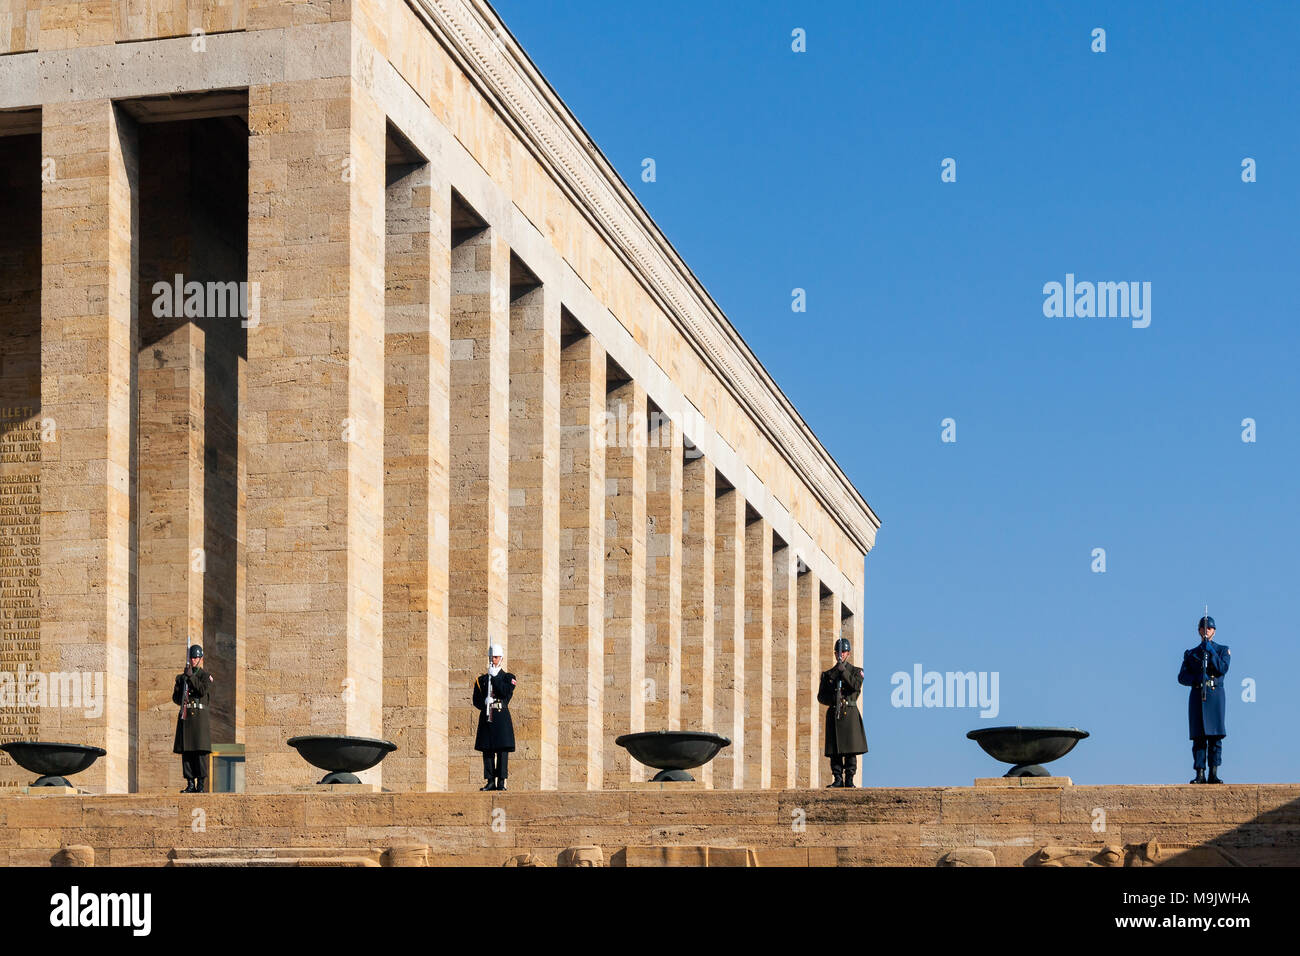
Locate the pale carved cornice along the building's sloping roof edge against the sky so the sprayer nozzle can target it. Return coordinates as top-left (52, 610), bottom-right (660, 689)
top-left (411, 0), bottom-right (880, 551)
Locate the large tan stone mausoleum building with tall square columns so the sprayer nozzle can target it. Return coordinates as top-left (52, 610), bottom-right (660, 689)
top-left (0, 0), bottom-right (880, 792)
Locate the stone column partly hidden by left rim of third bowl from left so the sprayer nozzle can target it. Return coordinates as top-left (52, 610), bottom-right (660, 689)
top-left (605, 381), bottom-right (646, 788)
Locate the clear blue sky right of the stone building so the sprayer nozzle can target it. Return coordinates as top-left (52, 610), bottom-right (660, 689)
top-left (495, 0), bottom-right (1300, 786)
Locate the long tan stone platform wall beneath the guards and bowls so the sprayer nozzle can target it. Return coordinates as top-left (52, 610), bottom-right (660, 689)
top-left (0, 784), bottom-right (1300, 866)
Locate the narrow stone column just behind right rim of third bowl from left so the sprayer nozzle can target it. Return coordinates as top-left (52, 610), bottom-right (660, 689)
top-left (714, 488), bottom-right (745, 790)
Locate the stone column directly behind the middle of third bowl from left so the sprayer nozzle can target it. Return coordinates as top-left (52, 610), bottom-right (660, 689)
top-left (645, 412), bottom-right (684, 730)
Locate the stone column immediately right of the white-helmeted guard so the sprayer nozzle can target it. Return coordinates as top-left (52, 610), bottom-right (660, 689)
top-left (510, 285), bottom-right (560, 790)
